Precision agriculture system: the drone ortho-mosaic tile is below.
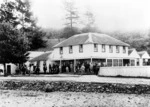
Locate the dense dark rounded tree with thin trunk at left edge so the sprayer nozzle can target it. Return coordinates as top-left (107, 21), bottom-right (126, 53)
top-left (0, 23), bottom-right (29, 76)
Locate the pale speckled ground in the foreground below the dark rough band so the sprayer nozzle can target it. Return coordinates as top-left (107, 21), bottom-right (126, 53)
top-left (0, 90), bottom-right (150, 107)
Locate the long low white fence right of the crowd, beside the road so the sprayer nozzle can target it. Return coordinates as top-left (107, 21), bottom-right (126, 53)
top-left (98, 66), bottom-right (150, 77)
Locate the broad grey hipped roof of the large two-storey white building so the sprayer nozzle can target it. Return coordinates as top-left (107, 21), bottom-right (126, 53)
top-left (54, 33), bottom-right (129, 48)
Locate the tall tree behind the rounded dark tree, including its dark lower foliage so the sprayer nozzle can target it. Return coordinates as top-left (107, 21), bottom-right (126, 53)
top-left (0, 0), bottom-right (46, 50)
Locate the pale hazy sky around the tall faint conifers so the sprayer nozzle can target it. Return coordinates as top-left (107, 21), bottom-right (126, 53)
top-left (0, 0), bottom-right (150, 31)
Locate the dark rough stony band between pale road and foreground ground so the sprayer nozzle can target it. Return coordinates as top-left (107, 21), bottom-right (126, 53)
top-left (0, 80), bottom-right (150, 94)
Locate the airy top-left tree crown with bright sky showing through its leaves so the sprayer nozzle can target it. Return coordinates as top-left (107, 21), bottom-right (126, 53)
top-left (0, 0), bottom-right (36, 28)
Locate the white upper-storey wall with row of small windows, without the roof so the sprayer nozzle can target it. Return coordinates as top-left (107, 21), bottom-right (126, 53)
top-left (53, 44), bottom-right (129, 66)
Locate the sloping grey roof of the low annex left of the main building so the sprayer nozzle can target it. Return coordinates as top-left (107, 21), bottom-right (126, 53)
top-left (30, 52), bottom-right (52, 62)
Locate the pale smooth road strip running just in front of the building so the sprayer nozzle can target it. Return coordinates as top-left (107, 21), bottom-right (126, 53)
top-left (0, 74), bottom-right (150, 85)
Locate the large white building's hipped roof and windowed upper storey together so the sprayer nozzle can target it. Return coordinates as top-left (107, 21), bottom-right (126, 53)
top-left (52, 33), bottom-right (130, 73)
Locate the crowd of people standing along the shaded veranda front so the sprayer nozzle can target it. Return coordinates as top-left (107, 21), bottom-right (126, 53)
top-left (16, 61), bottom-right (104, 75)
